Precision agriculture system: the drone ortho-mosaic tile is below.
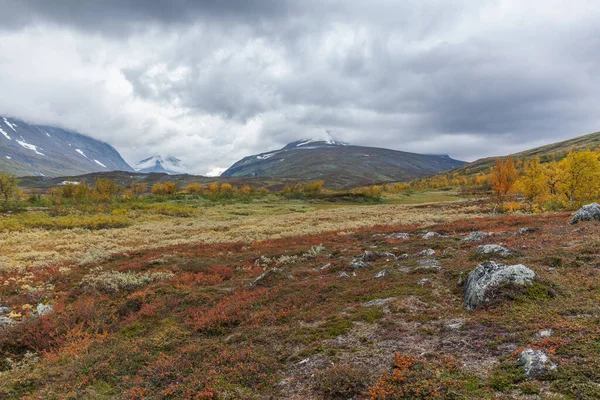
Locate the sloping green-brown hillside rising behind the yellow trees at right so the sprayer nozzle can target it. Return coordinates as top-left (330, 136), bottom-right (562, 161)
top-left (457, 132), bottom-right (600, 175)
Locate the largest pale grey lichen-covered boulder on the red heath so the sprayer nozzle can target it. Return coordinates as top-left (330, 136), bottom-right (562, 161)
top-left (465, 261), bottom-right (535, 310)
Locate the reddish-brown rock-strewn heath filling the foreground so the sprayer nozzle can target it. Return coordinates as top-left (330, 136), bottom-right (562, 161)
top-left (0, 210), bottom-right (600, 399)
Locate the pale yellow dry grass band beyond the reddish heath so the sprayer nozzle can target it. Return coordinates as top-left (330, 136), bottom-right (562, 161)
top-left (0, 202), bottom-right (479, 269)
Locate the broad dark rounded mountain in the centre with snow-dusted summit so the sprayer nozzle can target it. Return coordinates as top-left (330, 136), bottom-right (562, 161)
top-left (221, 139), bottom-right (464, 187)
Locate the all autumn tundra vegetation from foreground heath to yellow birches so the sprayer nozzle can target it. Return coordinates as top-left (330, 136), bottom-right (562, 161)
top-left (0, 164), bottom-right (600, 399)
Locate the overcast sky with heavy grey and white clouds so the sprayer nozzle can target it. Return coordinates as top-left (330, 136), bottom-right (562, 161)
top-left (0, 0), bottom-right (600, 175)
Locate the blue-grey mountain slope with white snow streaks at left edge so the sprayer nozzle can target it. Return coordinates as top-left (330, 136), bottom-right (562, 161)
top-left (0, 116), bottom-right (133, 176)
